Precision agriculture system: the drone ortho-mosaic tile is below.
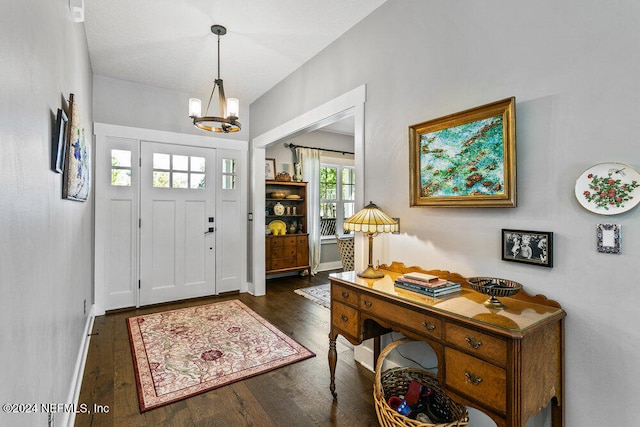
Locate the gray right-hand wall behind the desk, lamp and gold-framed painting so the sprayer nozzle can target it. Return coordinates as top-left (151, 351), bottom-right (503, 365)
top-left (251, 0), bottom-right (640, 427)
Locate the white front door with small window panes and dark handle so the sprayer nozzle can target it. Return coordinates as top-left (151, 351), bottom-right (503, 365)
top-left (139, 141), bottom-right (217, 305)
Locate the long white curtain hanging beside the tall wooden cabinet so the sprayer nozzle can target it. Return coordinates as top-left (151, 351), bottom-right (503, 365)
top-left (296, 148), bottom-right (320, 275)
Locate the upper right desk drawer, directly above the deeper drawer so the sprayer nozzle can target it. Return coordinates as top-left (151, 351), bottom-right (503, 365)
top-left (445, 323), bottom-right (507, 366)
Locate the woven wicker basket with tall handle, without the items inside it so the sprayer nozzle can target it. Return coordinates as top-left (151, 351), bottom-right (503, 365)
top-left (373, 338), bottom-right (469, 427)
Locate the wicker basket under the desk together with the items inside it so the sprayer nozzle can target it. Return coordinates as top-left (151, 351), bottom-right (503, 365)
top-left (373, 338), bottom-right (469, 427)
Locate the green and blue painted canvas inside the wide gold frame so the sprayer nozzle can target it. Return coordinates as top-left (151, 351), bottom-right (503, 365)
top-left (419, 114), bottom-right (505, 197)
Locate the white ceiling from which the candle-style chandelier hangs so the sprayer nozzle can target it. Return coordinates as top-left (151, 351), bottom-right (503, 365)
top-left (85, 0), bottom-right (386, 115)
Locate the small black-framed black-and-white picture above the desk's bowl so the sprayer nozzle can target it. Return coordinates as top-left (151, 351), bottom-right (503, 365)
top-left (502, 229), bottom-right (553, 267)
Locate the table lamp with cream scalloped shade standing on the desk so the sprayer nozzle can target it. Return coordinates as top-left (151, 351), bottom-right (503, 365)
top-left (342, 202), bottom-right (398, 279)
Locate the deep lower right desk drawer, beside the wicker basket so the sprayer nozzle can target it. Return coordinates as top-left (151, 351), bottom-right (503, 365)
top-left (444, 347), bottom-right (507, 412)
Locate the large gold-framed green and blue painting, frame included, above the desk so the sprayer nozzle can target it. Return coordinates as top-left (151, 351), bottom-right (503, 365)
top-left (409, 97), bottom-right (516, 207)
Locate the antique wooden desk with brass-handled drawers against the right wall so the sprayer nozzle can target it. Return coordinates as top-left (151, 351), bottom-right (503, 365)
top-left (329, 263), bottom-right (566, 427)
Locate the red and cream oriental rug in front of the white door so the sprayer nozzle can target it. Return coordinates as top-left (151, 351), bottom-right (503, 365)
top-left (127, 300), bottom-right (315, 412)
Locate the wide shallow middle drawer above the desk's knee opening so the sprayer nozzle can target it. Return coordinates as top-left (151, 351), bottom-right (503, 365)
top-left (360, 295), bottom-right (442, 339)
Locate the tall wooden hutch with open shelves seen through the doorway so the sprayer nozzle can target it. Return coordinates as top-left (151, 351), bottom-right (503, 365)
top-left (265, 181), bottom-right (309, 274)
